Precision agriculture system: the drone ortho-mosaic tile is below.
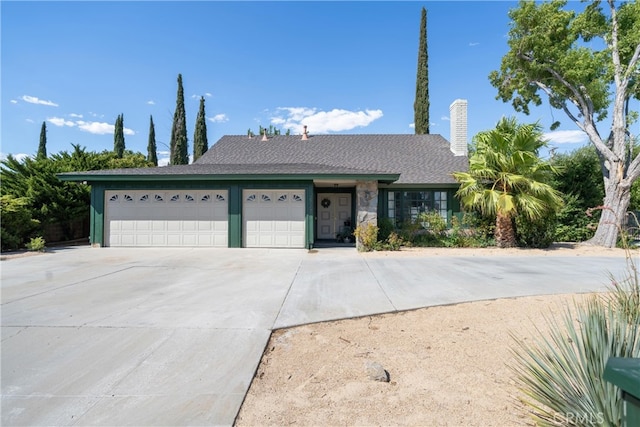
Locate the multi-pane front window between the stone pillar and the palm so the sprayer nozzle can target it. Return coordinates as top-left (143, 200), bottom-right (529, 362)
top-left (387, 190), bottom-right (448, 225)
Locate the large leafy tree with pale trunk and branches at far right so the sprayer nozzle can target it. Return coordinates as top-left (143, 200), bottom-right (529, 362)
top-left (489, 0), bottom-right (640, 247)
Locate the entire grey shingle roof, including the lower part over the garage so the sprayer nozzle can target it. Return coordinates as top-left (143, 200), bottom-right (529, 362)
top-left (59, 135), bottom-right (468, 184)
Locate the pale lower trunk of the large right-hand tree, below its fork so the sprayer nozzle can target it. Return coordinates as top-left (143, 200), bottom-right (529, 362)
top-left (585, 178), bottom-right (631, 248)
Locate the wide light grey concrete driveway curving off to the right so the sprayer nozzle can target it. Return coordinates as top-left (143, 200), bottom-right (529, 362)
top-left (0, 247), bottom-right (625, 426)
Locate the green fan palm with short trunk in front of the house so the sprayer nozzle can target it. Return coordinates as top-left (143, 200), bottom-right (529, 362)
top-left (453, 118), bottom-right (562, 248)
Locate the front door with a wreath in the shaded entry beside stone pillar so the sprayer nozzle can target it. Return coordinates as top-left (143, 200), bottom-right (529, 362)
top-left (316, 193), bottom-right (351, 240)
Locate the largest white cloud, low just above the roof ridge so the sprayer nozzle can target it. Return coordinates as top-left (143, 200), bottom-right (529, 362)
top-left (271, 107), bottom-right (383, 134)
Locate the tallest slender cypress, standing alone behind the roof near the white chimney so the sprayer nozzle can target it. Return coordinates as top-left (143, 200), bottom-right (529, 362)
top-left (413, 7), bottom-right (429, 135)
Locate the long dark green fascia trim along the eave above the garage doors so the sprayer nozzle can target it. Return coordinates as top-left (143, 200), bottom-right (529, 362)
top-left (57, 172), bottom-right (400, 184)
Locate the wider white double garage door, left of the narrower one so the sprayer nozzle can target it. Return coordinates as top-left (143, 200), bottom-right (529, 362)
top-left (105, 190), bottom-right (229, 248)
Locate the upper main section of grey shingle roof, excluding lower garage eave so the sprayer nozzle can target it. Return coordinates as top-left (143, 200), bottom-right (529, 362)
top-left (198, 134), bottom-right (468, 184)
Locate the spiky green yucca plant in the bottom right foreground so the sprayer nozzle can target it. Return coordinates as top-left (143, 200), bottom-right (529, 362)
top-left (511, 257), bottom-right (640, 427)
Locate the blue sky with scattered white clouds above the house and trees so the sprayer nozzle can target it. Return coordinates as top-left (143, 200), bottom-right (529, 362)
top-left (0, 1), bottom-right (608, 166)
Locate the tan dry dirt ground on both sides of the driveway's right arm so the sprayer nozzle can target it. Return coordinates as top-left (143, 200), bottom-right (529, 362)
top-left (236, 245), bottom-right (625, 426)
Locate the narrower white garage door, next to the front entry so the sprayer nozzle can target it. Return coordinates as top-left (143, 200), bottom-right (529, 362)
top-left (242, 190), bottom-right (305, 248)
